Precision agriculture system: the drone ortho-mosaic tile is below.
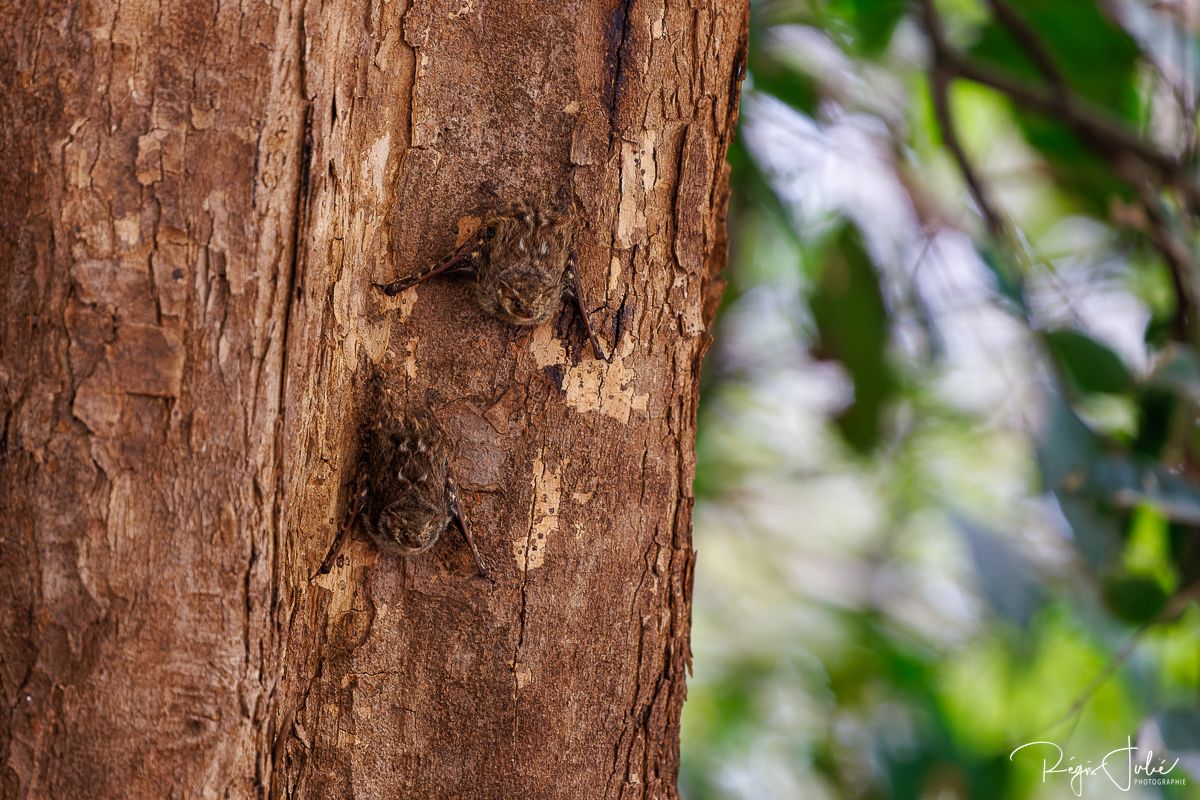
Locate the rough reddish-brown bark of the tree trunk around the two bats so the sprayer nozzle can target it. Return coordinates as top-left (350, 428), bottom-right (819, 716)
top-left (0, 0), bottom-right (746, 799)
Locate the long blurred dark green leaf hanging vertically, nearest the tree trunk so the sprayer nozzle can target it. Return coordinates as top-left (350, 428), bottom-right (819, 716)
top-left (810, 224), bottom-right (896, 453)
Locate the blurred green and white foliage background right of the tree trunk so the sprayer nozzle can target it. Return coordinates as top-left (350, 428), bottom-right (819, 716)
top-left (680, 0), bottom-right (1200, 800)
